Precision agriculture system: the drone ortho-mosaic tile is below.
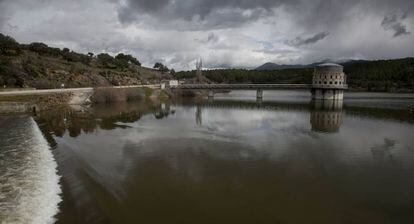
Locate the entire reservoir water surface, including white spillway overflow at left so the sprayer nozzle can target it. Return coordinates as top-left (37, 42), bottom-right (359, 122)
top-left (0, 91), bottom-right (414, 224)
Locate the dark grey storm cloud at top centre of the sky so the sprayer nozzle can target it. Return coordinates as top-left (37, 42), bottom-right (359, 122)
top-left (118, 0), bottom-right (298, 30)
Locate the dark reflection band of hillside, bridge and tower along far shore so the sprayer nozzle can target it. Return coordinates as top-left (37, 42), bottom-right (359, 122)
top-left (36, 99), bottom-right (414, 147)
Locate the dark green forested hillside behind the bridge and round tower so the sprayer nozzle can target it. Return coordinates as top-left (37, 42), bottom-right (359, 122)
top-left (175, 58), bottom-right (414, 92)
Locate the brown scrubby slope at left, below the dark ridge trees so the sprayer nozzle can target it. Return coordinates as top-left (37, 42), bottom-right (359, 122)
top-left (0, 50), bottom-right (170, 89)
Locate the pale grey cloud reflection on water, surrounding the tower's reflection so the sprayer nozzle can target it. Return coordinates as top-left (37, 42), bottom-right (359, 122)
top-left (115, 106), bottom-right (412, 170)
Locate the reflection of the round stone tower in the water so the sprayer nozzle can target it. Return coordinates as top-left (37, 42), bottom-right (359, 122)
top-left (310, 100), bottom-right (342, 133)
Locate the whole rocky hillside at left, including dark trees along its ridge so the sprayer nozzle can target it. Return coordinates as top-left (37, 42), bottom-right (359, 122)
top-left (0, 33), bottom-right (173, 89)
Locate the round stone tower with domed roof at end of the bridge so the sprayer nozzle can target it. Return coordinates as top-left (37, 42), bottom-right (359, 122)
top-left (312, 63), bottom-right (348, 100)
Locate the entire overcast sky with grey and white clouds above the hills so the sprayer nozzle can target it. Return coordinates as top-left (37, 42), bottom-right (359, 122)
top-left (0, 0), bottom-right (414, 70)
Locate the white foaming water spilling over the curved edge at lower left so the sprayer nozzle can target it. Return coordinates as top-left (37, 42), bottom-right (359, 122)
top-left (0, 118), bottom-right (61, 224)
